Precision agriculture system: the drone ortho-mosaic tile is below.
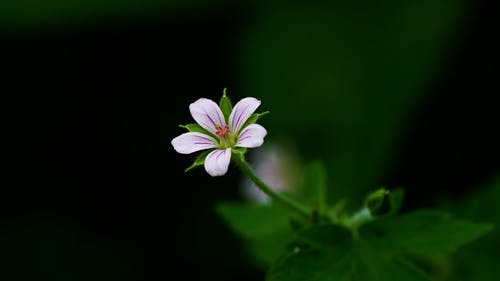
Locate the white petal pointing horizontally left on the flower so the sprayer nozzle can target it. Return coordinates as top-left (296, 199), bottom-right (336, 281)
top-left (172, 132), bottom-right (217, 154)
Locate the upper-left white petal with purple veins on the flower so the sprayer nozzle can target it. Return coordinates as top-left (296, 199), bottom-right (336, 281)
top-left (189, 98), bottom-right (226, 134)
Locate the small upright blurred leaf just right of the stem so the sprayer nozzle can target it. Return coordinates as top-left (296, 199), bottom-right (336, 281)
top-left (303, 161), bottom-right (327, 213)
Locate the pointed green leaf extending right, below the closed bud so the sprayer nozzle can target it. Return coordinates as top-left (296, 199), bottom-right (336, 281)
top-left (360, 211), bottom-right (492, 254)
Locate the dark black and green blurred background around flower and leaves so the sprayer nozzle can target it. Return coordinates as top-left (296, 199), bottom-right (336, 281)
top-left (0, 0), bottom-right (500, 281)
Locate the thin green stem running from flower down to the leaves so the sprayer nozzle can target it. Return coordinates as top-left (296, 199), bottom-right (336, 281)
top-left (234, 155), bottom-right (311, 218)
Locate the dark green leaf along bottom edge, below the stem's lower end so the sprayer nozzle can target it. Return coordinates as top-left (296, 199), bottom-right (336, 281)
top-left (266, 225), bottom-right (429, 281)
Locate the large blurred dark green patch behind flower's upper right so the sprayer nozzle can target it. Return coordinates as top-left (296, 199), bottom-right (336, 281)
top-left (239, 0), bottom-right (463, 198)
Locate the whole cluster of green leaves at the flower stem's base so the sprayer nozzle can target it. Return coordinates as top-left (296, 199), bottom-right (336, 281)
top-left (216, 162), bottom-right (492, 281)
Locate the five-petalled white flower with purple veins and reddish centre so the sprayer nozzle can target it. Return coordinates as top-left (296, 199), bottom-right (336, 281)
top-left (172, 97), bottom-right (267, 177)
